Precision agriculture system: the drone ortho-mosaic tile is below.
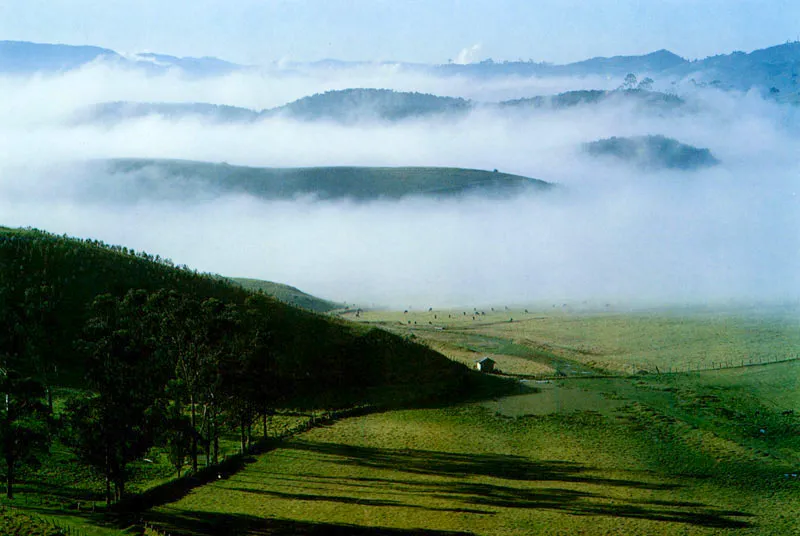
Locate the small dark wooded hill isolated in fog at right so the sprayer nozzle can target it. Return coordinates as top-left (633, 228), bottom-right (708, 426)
top-left (585, 136), bottom-right (719, 170)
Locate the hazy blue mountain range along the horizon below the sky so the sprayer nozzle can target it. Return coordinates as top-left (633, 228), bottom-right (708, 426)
top-left (6, 41), bottom-right (800, 94)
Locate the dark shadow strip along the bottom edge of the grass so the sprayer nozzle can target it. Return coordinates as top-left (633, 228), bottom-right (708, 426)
top-left (148, 511), bottom-right (472, 536)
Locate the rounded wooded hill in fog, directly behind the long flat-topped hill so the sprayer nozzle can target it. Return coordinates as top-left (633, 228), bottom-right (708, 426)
top-left (263, 88), bottom-right (472, 122)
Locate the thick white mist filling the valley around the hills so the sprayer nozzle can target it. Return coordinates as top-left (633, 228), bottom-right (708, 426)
top-left (0, 66), bottom-right (800, 307)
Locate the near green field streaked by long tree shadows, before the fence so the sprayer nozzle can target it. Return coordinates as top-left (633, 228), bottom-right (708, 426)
top-left (148, 363), bottom-right (800, 535)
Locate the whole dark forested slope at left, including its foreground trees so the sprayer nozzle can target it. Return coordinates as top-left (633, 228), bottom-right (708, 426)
top-left (0, 228), bottom-right (470, 504)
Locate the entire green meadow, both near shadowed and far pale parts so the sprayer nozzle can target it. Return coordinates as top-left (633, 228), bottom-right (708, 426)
top-left (134, 310), bottom-right (800, 535)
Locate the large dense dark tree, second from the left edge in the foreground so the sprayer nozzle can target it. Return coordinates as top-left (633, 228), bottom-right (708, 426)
top-left (65, 291), bottom-right (168, 504)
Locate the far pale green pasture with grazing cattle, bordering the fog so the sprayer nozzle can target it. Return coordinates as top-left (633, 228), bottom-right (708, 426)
top-left (346, 308), bottom-right (800, 375)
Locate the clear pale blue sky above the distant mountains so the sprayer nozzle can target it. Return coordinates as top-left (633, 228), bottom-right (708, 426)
top-left (0, 0), bottom-right (800, 63)
